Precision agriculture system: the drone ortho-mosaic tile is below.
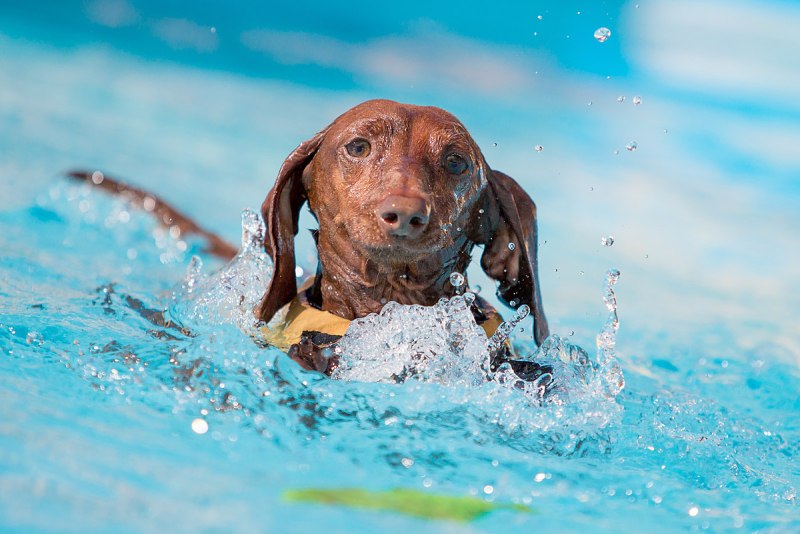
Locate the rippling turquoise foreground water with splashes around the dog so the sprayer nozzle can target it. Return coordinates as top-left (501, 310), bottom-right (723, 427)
top-left (0, 182), bottom-right (800, 531)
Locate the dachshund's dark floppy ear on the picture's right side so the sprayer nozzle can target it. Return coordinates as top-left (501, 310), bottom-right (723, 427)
top-left (481, 170), bottom-right (550, 345)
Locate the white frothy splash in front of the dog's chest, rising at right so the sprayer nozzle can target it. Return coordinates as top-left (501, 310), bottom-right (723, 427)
top-left (333, 271), bottom-right (624, 427)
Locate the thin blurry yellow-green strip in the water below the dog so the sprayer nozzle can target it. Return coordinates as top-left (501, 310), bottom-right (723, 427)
top-left (283, 488), bottom-right (533, 522)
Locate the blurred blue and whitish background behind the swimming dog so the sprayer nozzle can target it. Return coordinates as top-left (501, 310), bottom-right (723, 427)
top-left (0, 0), bottom-right (800, 362)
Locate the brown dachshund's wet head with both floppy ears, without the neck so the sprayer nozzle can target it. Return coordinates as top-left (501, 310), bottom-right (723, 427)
top-left (259, 100), bottom-right (548, 343)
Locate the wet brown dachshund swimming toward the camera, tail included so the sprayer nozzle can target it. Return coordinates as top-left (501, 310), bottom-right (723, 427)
top-left (73, 100), bottom-right (548, 373)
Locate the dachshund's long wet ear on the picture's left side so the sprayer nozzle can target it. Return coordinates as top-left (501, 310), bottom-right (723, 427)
top-left (258, 128), bottom-right (327, 322)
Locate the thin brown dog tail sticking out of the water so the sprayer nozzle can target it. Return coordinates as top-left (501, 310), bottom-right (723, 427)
top-left (67, 171), bottom-right (237, 260)
